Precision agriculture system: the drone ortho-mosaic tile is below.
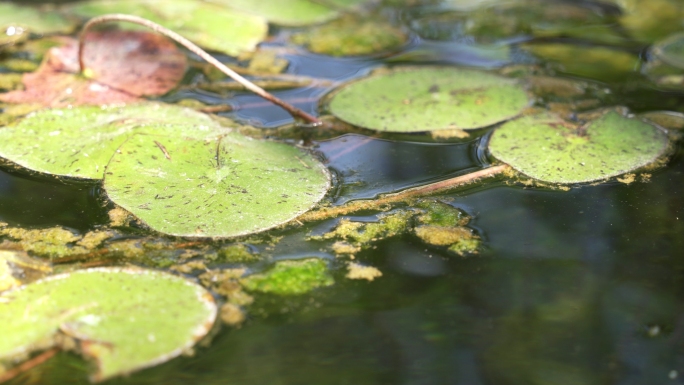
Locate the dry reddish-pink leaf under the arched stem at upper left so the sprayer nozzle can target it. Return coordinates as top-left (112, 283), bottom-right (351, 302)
top-left (0, 31), bottom-right (187, 107)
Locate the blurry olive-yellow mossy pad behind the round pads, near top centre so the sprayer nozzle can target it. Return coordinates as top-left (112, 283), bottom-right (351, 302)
top-left (293, 16), bottom-right (407, 56)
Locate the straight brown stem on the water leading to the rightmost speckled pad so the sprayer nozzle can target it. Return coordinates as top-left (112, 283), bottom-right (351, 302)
top-left (297, 164), bottom-right (511, 222)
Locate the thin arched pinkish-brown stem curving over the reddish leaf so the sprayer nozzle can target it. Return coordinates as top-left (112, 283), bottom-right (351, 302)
top-left (78, 13), bottom-right (321, 125)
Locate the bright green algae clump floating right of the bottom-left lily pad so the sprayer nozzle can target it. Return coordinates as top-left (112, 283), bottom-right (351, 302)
top-left (240, 258), bottom-right (335, 295)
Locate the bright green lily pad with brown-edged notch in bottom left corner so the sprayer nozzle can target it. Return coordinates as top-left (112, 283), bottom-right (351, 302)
top-left (0, 268), bottom-right (217, 381)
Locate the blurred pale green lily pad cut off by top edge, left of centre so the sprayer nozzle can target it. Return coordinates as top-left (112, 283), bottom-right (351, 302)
top-left (210, 0), bottom-right (338, 27)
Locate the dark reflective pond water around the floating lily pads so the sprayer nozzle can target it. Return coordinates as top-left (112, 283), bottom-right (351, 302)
top-left (0, 1), bottom-right (684, 385)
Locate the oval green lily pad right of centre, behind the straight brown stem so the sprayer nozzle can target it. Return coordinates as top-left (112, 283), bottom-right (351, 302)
top-left (329, 67), bottom-right (530, 132)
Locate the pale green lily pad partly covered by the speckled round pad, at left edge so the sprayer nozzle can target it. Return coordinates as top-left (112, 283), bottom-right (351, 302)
top-left (0, 103), bottom-right (225, 179)
